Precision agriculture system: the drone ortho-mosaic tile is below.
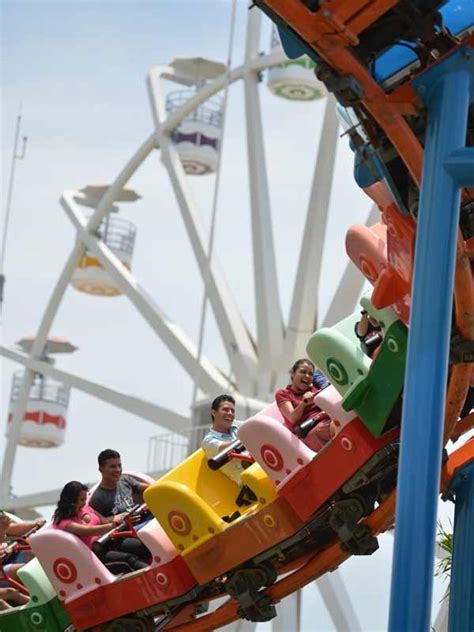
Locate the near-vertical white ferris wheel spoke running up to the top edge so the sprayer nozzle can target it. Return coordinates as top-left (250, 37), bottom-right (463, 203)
top-left (244, 11), bottom-right (283, 372)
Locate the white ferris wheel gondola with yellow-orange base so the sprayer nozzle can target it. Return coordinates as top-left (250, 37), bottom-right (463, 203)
top-left (71, 215), bottom-right (137, 296)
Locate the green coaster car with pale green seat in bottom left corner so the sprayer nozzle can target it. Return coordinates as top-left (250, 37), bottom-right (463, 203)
top-left (0, 559), bottom-right (71, 632)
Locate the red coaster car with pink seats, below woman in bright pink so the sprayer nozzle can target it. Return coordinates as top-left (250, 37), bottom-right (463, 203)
top-left (31, 506), bottom-right (196, 630)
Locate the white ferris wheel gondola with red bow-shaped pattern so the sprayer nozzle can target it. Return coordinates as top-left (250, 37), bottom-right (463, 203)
top-left (7, 371), bottom-right (69, 448)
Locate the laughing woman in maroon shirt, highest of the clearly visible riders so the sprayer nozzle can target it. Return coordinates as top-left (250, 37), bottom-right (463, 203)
top-left (275, 358), bottom-right (333, 452)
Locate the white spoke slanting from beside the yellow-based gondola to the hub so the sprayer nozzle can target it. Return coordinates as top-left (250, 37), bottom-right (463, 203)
top-left (61, 191), bottom-right (228, 393)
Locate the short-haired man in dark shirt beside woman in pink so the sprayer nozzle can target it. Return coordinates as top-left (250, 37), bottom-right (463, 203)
top-left (89, 449), bottom-right (148, 518)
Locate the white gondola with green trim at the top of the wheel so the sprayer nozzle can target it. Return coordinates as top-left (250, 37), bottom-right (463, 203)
top-left (267, 27), bottom-right (327, 101)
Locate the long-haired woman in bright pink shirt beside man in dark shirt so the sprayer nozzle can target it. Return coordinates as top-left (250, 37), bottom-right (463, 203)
top-left (53, 481), bottom-right (150, 573)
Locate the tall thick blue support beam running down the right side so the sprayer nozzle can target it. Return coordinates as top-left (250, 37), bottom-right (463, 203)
top-left (389, 47), bottom-right (474, 632)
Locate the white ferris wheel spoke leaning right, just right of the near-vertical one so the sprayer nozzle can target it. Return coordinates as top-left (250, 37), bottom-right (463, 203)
top-left (284, 95), bottom-right (339, 366)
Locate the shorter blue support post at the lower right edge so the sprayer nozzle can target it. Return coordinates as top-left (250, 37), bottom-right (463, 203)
top-left (448, 462), bottom-right (474, 632)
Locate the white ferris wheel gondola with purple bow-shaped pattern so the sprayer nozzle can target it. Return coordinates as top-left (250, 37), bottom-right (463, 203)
top-left (166, 89), bottom-right (222, 176)
